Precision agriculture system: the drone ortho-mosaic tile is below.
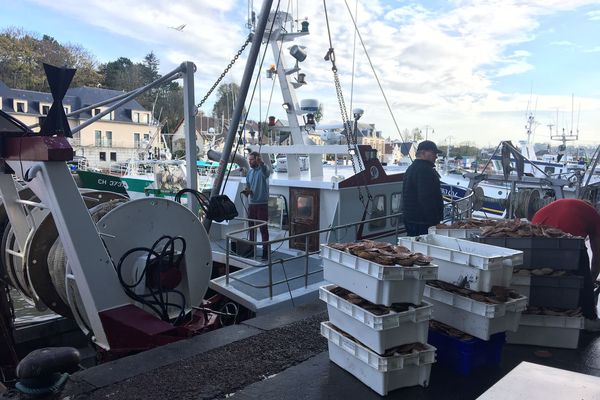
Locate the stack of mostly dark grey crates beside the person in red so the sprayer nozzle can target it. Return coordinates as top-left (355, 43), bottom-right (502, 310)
top-left (476, 237), bottom-right (585, 349)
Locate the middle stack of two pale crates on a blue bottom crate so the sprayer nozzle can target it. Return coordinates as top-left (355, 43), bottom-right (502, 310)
top-left (399, 230), bottom-right (527, 373)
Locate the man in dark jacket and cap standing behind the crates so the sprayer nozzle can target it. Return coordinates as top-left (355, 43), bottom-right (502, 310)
top-left (402, 140), bottom-right (444, 236)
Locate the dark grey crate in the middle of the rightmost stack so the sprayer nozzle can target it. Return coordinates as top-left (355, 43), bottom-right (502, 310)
top-left (529, 275), bottom-right (583, 309)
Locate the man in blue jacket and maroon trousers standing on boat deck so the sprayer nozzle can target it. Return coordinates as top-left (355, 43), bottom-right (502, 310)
top-left (242, 151), bottom-right (271, 260)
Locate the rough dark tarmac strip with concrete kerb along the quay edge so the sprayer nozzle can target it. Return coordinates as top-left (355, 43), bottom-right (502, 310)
top-left (63, 304), bottom-right (327, 399)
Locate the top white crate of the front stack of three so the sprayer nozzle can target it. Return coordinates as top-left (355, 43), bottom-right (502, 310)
top-left (321, 245), bottom-right (438, 306)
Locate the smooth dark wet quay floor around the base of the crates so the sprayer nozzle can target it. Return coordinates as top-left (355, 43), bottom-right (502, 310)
top-left (233, 334), bottom-right (600, 400)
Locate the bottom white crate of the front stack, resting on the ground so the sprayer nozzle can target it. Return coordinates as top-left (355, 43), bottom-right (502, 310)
top-left (321, 322), bottom-right (435, 396)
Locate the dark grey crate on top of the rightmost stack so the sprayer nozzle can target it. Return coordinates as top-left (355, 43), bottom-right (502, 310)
top-left (471, 236), bottom-right (585, 271)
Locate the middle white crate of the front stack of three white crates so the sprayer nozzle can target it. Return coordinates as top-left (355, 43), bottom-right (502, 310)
top-left (319, 285), bottom-right (433, 354)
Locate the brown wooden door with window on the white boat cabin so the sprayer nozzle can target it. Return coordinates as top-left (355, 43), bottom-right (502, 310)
top-left (289, 188), bottom-right (320, 251)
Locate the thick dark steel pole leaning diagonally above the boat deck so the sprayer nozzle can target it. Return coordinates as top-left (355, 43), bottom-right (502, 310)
top-left (204, 0), bottom-right (273, 232)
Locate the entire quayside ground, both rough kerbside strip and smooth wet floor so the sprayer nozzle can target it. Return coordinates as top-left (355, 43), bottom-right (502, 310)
top-left (8, 301), bottom-right (600, 400)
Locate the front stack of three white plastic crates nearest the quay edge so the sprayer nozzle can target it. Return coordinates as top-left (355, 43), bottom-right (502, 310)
top-left (319, 245), bottom-right (437, 395)
